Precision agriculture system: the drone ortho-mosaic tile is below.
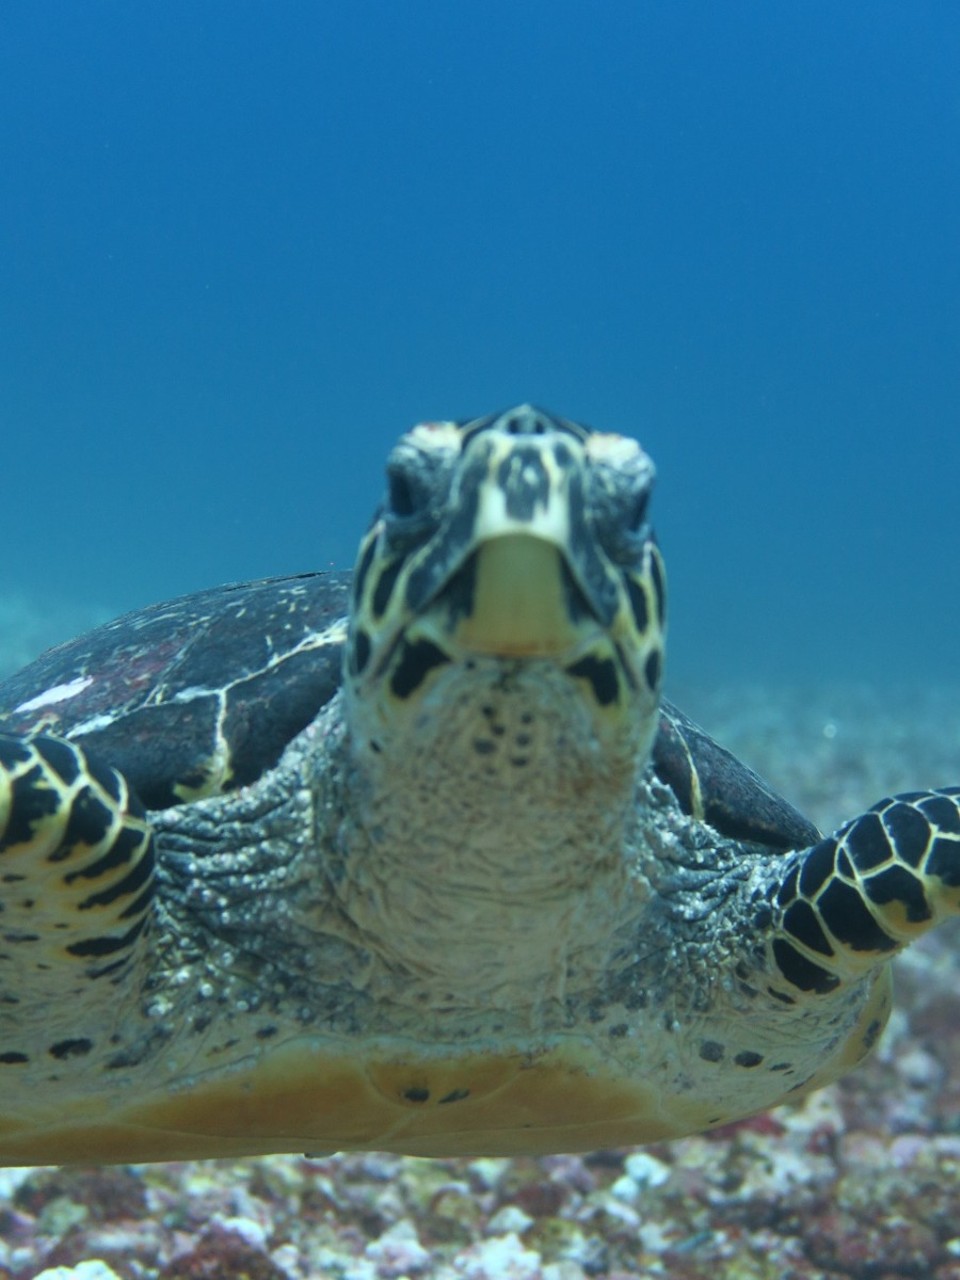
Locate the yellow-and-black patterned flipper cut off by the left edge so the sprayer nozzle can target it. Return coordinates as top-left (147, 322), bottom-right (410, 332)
top-left (0, 733), bottom-right (154, 998)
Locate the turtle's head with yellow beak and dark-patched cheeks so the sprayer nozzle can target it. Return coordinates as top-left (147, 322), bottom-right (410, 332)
top-left (344, 404), bottom-right (664, 783)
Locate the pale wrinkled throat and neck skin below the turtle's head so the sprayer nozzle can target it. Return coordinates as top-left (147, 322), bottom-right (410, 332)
top-left (337, 658), bottom-right (648, 1020)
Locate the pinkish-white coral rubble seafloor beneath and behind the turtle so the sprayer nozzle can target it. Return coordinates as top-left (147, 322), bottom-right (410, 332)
top-left (0, 611), bottom-right (960, 1280)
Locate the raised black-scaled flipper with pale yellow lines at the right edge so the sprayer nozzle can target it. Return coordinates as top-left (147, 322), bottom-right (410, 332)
top-left (772, 787), bottom-right (960, 995)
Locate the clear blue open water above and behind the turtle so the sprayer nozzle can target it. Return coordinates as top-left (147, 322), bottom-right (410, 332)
top-left (0, 0), bottom-right (960, 681)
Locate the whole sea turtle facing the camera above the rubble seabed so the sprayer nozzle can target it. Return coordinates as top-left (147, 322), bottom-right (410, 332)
top-left (0, 406), bottom-right (960, 1165)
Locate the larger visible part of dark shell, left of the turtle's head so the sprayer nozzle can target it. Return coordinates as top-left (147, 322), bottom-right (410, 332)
top-left (0, 573), bottom-right (351, 809)
